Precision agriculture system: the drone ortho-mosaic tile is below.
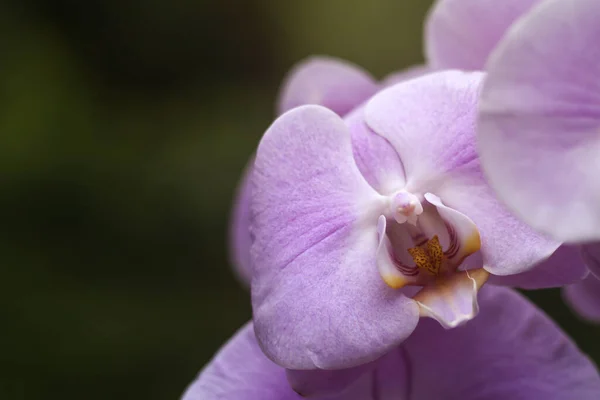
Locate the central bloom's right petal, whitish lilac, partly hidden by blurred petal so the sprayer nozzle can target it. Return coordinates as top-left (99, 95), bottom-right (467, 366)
top-left (365, 71), bottom-right (559, 275)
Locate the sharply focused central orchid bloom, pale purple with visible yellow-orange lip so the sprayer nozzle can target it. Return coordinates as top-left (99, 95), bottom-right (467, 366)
top-left (245, 71), bottom-right (585, 369)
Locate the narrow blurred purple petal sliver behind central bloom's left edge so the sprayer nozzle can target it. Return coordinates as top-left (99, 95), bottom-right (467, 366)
top-left (229, 158), bottom-right (254, 285)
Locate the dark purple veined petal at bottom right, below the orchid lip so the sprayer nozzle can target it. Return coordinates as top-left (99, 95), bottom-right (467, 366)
top-left (403, 286), bottom-right (600, 400)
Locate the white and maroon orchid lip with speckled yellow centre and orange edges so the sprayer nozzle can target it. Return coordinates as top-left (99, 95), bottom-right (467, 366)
top-left (377, 191), bottom-right (489, 328)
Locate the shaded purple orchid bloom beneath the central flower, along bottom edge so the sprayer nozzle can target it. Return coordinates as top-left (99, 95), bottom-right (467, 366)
top-left (182, 286), bottom-right (600, 400)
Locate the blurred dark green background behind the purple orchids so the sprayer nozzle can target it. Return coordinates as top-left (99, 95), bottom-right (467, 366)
top-left (0, 0), bottom-right (600, 400)
